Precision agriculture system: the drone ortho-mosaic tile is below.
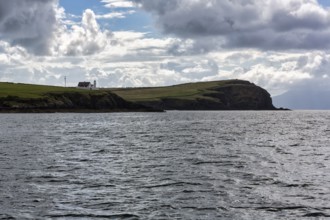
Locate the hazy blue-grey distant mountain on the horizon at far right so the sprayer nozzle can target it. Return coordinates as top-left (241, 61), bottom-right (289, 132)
top-left (273, 89), bottom-right (330, 110)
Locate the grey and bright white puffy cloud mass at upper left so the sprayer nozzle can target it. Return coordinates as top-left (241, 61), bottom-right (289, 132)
top-left (0, 0), bottom-right (116, 56)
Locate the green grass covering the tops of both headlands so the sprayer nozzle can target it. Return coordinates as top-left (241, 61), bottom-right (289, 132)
top-left (0, 80), bottom-right (245, 102)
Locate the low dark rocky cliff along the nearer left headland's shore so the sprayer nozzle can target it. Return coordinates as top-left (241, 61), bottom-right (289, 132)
top-left (0, 92), bottom-right (159, 112)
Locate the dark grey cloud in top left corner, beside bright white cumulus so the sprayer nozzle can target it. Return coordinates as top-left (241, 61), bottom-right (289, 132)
top-left (0, 0), bottom-right (57, 54)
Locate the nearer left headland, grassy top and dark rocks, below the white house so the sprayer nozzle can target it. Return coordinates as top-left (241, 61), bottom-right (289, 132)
top-left (0, 82), bottom-right (160, 112)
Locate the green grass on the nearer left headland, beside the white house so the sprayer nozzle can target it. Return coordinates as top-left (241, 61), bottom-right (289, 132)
top-left (0, 82), bottom-right (97, 99)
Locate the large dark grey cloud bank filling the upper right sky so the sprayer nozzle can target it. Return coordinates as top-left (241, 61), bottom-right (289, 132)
top-left (134, 0), bottom-right (330, 50)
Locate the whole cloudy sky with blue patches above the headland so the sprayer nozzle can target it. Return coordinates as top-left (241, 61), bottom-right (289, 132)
top-left (0, 0), bottom-right (330, 96)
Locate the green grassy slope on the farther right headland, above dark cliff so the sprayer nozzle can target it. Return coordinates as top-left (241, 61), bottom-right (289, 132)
top-left (111, 80), bottom-right (235, 102)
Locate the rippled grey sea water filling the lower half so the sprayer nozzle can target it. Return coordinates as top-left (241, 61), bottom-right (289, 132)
top-left (0, 111), bottom-right (330, 219)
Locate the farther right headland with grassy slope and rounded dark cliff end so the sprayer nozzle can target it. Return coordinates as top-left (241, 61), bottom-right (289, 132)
top-left (113, 80), bottom-right (276, 110)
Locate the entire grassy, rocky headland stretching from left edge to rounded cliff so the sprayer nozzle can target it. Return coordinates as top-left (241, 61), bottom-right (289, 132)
top-left (0, 80), bottom-right (276, 112)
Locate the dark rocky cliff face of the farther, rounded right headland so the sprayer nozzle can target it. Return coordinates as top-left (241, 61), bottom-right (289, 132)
top-left (138, 80), bottom-right (276, 110)
